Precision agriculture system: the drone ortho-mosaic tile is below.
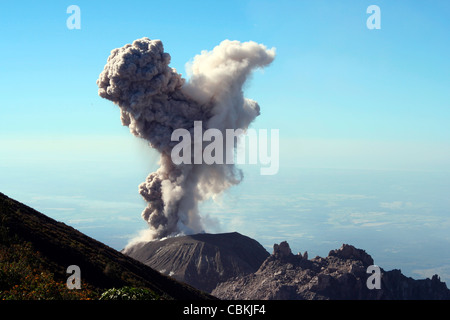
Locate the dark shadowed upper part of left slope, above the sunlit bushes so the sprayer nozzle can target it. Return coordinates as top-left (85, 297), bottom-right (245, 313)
top-left (0, 193), bottom-right (213, 300)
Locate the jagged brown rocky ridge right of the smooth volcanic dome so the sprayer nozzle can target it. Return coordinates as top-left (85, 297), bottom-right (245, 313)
top-left (212, 242), bottom-right (450, 300)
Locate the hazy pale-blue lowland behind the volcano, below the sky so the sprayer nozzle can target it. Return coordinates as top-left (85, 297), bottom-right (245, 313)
top-left (1, 149), bottom-right (450, 283)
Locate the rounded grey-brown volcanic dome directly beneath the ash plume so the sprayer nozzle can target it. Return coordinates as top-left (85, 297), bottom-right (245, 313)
top-left (123, 232), bottom-right (270, 292)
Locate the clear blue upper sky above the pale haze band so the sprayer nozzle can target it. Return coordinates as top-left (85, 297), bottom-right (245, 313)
top-left (0, 1), bottom-right (450, 169)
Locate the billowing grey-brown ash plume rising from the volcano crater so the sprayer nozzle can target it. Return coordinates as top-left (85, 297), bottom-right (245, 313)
top-left (97, 38), bottom-right (275, 239)
